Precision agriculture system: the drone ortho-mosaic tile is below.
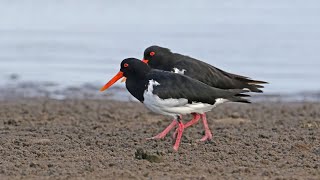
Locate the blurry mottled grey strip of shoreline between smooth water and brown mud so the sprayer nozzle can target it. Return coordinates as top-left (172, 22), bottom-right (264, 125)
top-left (0, 81), bottom-right (320, 102)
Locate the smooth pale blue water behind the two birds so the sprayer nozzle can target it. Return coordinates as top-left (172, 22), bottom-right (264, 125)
top-left (0, 0), bottom-right (320, 93)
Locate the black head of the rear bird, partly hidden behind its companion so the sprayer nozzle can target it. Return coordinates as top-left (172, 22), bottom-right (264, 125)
top-left (142, 46), bottom-right (173, 68)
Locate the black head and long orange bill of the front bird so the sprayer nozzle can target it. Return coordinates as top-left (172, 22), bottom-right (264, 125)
top-left (100, 58), bottom-right (151, 91)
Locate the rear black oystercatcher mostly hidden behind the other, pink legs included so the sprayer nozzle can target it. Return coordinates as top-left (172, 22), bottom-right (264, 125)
top-left (142, 46), bottom-right (267, 141)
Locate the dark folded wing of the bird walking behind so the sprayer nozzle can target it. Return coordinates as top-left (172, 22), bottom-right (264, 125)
top-left (173, 53), bottom-right (266, 92)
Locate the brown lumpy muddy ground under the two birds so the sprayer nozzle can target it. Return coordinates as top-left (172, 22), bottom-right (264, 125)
top-left (0, 99), bottom-right (320, 179)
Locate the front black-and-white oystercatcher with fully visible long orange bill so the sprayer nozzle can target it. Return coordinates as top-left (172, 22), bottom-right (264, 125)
top-left (100, 58), bottom-right (250, 150)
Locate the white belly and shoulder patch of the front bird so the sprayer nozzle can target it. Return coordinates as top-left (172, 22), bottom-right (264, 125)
top-left (143, 80), bottom-right (227, 118)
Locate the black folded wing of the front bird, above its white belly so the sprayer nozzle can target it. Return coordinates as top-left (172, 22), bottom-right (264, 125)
top-left (147, 69), bottom-right (248, 104)
